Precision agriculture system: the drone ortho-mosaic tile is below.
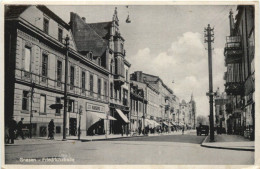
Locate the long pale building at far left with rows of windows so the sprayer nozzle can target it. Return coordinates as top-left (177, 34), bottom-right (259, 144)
top-left (5, 5), bottom-right (109, 136)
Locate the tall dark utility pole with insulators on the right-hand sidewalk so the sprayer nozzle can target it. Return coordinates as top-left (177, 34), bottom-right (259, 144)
top-left (204, 24), bottom-right (214, 142)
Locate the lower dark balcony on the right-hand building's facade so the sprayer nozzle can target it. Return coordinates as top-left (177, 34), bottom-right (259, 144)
top-left (225, 82), bottom-right (244, 95)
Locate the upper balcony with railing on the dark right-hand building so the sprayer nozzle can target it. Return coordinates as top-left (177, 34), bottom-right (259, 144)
top-left (224, 36), bottom-right (243, 64)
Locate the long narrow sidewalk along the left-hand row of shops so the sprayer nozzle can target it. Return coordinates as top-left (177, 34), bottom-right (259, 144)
top-left (5, 131), bottom-right (189, 146)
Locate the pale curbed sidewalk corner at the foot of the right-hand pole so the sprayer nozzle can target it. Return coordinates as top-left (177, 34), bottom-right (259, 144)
top-left (201, 134), bottom-right (255, 151)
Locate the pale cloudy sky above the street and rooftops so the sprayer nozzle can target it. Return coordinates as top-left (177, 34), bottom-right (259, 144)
top-left (48, 5), bottom-right (239, 116)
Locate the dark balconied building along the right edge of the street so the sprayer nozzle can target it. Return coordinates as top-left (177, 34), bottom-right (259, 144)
top-left (224, 5), bottom-right (255, 139)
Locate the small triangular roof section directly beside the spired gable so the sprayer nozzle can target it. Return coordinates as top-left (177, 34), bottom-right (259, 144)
top-left (88, 21), bottom-right (112, 44)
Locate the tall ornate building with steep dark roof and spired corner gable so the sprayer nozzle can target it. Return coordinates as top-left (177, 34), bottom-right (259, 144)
top-left (70, 9), bottom-right (131, 134)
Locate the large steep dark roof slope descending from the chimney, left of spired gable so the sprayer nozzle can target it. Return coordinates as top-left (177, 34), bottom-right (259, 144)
top-left (70, 12), bottom-right (107, 56)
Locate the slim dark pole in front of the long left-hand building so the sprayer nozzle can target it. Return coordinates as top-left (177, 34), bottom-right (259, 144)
top-left (62, 35), bottom-right (70, 141)
